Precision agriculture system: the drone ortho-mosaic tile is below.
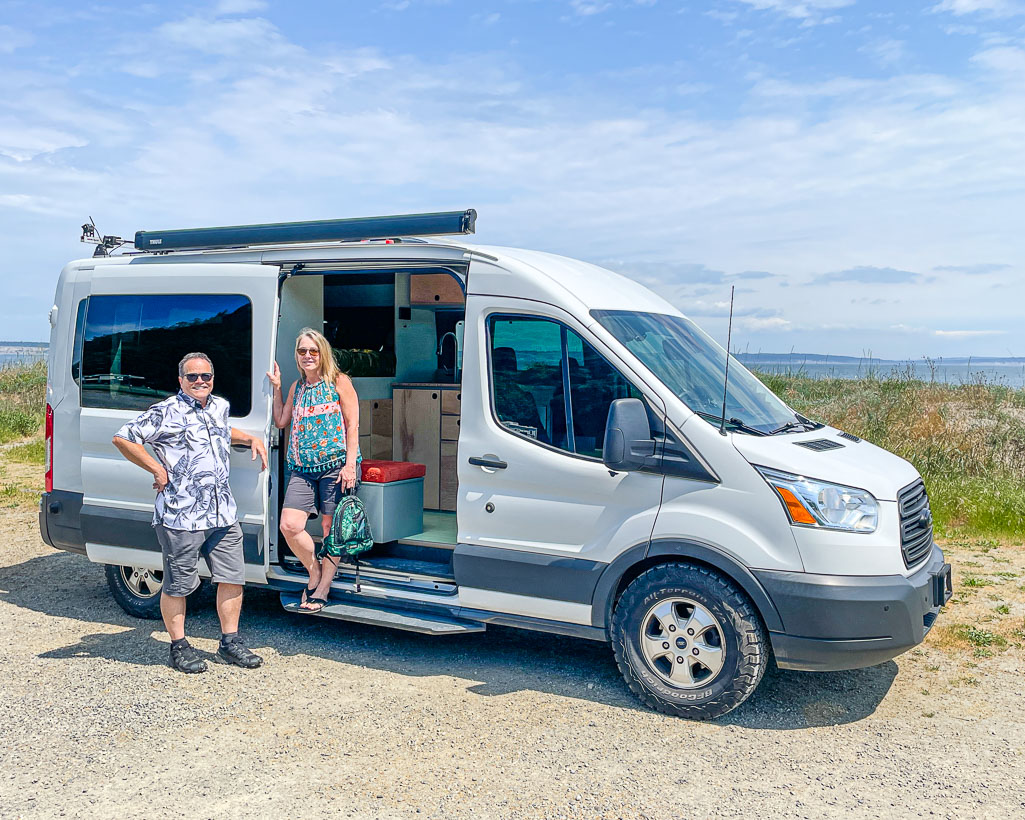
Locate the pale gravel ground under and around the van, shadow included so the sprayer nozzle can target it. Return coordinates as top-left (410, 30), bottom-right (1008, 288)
top-left (0, 487), bottom-right (1025, 820)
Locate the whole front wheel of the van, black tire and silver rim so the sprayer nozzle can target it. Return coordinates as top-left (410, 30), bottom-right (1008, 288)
top-left (612, 564), bottom-right (769, 721)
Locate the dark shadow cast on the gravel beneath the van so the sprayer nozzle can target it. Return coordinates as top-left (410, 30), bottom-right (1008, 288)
top-left (0, 552), bottom-right (897, 730)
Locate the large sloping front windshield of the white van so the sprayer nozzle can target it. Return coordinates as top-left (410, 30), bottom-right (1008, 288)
top-left (591, 311), bottom-right (805, 435)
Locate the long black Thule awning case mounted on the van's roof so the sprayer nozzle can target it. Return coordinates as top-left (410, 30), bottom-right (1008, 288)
top-left (135, 208), bottom-right (477, 252)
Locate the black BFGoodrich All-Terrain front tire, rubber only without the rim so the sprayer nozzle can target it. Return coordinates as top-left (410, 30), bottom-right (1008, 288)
top-left (612, 563), bottom-right (772, 721)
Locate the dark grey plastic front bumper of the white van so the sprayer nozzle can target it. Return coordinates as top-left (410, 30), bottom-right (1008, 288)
top-left (753, 544), bottom-right (950, 671)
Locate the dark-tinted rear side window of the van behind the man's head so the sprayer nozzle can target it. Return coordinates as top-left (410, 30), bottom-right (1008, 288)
top-left (81, 293), bottom-right (253, 416)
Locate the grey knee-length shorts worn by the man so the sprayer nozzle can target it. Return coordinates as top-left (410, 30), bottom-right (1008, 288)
top-left (153, 522), bottom-right (246, 598)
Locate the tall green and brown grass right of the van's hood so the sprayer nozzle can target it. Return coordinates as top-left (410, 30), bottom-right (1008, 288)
top-left (760, 371), bottom-right (1025, 537)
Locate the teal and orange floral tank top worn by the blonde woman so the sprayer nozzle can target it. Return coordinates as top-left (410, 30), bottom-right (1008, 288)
top-left (285, 378), bottom-right (345, 473)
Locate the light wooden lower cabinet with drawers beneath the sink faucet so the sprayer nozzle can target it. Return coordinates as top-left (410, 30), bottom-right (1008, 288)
top-left (392, 384), bottom-right (459, 510)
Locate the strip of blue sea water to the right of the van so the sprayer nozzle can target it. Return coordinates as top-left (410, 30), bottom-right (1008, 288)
top-left (739, 355), bottom-right (1025, 388)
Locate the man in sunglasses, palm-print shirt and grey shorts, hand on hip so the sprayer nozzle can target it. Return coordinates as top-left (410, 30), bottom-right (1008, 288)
top-left (114, 353), bottom-right (267, 672)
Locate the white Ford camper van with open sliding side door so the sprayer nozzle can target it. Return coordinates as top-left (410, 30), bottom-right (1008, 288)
top-left (39, 211), bottom-right (950, 719)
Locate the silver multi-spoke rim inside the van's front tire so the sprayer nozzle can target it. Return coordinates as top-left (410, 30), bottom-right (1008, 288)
top-left (641, 598), bottom-right (726, 689)
